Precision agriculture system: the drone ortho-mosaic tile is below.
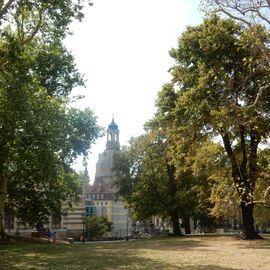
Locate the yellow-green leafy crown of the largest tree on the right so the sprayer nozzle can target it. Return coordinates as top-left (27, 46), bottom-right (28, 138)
top-left (171, 14), bottom-right (269, 198)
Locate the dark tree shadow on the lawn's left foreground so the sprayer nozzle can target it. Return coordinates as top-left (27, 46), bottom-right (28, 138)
top-left (0, 244), bottom-right (244, 270)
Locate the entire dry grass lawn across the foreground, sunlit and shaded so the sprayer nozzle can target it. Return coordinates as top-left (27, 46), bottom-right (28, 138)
top-left (0, 236), bottom-right (270, 270)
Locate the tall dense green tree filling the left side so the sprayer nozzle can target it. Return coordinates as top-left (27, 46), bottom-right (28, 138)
top-left (0, 0), bottom-right (101, 237)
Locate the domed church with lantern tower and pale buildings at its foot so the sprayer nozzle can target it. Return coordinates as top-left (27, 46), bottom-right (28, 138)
top-left (85, 118), bottom-right (131, 236)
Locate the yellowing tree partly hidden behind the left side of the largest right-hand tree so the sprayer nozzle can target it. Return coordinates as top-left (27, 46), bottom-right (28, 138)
top-left (153, 83), bottom-right (220, 233)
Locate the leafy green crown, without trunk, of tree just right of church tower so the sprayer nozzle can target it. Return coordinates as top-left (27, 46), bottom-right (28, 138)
top-left (113, 135), bottom-right (168, 220)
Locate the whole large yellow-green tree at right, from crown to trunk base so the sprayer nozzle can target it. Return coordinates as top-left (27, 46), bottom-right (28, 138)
top-left (167, 16), bottom-right (269, 239)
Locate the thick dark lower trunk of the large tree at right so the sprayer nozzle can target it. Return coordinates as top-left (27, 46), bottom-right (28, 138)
top-left (239, 202), bottom-right (262, 240)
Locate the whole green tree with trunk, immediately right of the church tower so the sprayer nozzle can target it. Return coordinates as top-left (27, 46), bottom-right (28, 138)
top-left (113, 134), bottom-right (181, 235)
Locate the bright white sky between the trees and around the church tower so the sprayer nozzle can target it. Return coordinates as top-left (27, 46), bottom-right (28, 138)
top-left (66, 0), bottom-right (203, 182)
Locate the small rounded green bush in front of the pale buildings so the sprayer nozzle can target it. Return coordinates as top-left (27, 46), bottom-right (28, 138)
top-left (85, 216), bottom-right (113, 237)
